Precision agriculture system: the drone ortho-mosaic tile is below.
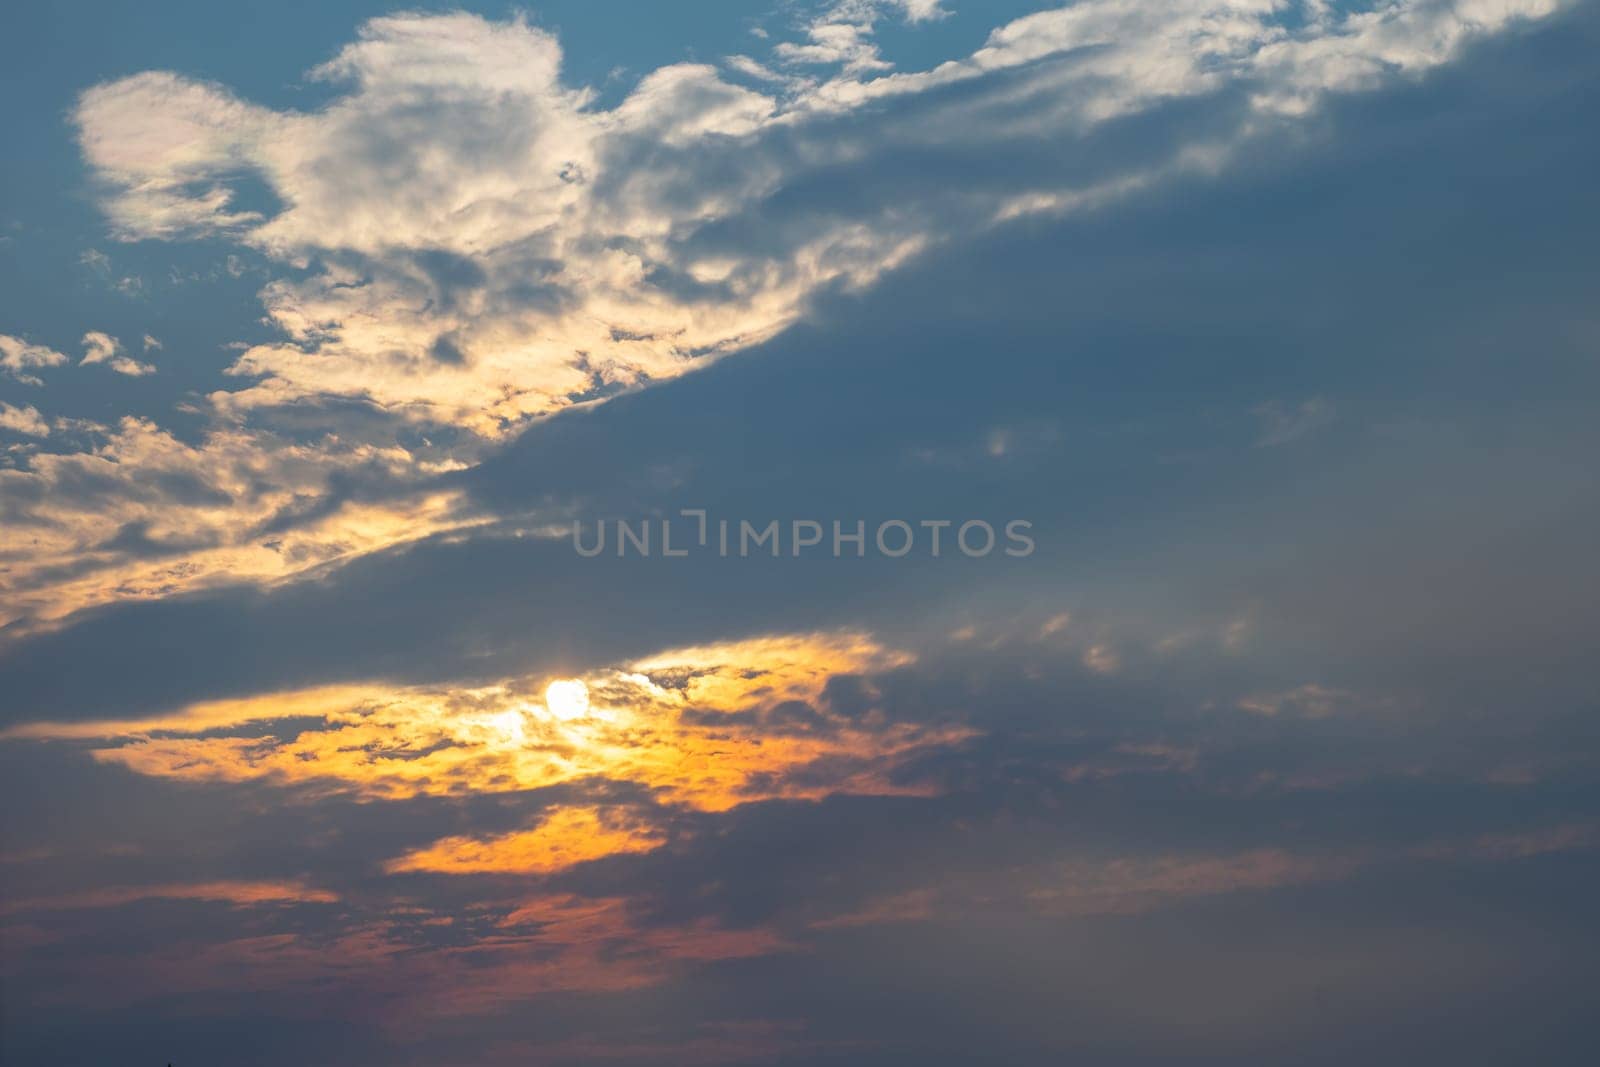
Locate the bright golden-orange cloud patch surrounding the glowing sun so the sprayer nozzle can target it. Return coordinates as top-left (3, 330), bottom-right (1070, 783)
top-left (21, 633), bottom-right (971, 811)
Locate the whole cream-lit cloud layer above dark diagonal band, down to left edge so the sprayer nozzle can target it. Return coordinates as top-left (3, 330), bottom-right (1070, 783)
top-left (3, 0), bottom-right (1555, 627)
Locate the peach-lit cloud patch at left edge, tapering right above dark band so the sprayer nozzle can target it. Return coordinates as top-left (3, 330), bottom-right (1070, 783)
top-left (0, 415), bottom-right (475, 625)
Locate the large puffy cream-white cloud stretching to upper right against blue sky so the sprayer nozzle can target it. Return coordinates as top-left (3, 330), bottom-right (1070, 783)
top-left (75, 0), bottom-right (1555, 435)
